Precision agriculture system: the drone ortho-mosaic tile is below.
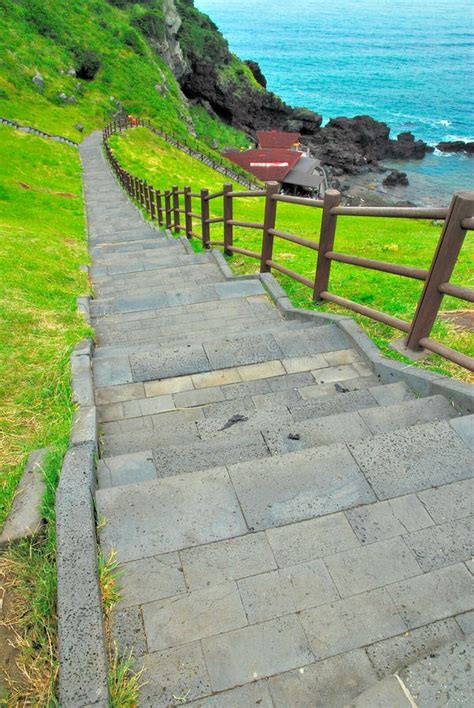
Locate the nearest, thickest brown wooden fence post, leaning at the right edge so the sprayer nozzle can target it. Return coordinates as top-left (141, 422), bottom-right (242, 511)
top-left (406, 192), bottom-right (474, 351)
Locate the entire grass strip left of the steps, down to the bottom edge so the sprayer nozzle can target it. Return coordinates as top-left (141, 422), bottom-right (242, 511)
top-left (0, 126), bottom-right (90, 706)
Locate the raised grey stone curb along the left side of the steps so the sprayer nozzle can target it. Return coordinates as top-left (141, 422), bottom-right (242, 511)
top-left (55, 338), bottom-right (109, 708)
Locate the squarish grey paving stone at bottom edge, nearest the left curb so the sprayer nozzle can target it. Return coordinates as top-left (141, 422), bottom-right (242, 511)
top-left (139, 642), bottom-right (212, 708)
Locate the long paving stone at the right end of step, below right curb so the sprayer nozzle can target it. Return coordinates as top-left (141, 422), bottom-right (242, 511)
top-left (360, 396), bottom-right (457, 435)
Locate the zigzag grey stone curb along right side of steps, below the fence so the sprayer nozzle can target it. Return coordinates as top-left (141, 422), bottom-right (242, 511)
top-left (212, 250), bottom-right (474, 413)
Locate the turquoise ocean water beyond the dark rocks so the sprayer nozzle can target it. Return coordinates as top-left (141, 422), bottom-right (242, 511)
top-left (195, 0), bottom-right (474, 201)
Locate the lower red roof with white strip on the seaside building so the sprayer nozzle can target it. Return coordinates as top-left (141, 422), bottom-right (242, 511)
top-left (223, 148), bottom-right (303, 182)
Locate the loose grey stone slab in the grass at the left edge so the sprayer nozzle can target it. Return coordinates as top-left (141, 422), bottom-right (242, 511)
top-left (0, 447), bottom-right (48, 548)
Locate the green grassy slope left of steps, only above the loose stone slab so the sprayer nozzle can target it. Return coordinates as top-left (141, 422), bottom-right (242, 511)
top-left (0, 127), bottom-right (88, 525)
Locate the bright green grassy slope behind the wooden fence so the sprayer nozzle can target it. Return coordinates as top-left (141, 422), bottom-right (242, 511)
top-left (111, 129), bottom-right (474, 379)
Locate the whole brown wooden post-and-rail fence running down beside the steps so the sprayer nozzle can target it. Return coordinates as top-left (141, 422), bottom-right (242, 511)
top-left (104, 119), bottom-right (474, 371)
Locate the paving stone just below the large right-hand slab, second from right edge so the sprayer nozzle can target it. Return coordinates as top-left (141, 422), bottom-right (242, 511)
top-left (346, 494), bottom-right (434, 543)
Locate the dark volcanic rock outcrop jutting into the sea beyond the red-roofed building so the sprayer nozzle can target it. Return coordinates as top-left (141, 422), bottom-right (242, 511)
top-left (310, 116), bottom-right (432, 174)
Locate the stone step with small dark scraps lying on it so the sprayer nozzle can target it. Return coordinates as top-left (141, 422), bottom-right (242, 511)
top-left (98, 392), bottom-right (453, 482)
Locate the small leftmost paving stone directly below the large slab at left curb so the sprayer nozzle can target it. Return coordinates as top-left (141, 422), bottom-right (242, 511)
top-left (118, 553), bottom-right (187, 608)
